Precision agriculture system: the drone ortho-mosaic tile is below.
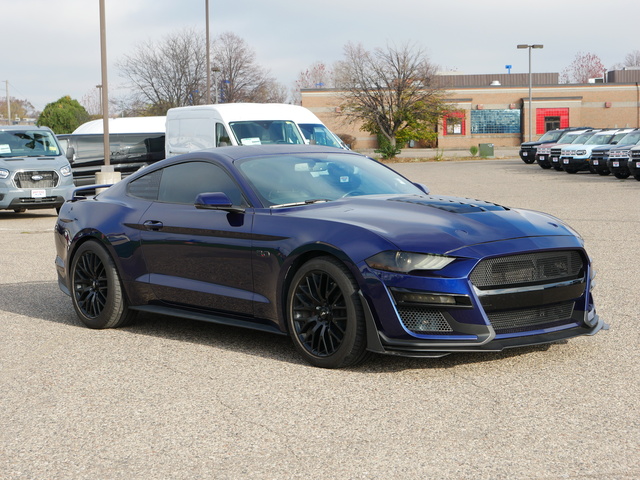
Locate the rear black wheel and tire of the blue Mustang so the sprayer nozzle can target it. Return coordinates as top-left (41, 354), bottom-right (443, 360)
top-left (70, 241), bottom-right (136, 328)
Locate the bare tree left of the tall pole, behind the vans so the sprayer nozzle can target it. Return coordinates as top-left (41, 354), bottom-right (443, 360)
top-left (118, 29), bottom-right (206, 115)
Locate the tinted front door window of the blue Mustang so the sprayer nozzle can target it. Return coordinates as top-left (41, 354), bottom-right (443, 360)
top-left (158, 161), bottom-right (246, 205)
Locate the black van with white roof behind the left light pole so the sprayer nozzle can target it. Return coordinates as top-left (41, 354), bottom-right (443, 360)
top-left (58, 117), bottom-right (165, 186)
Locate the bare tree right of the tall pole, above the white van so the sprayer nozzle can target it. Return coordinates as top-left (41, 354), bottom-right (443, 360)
top-left (213, 32), bottom-right (287, 103)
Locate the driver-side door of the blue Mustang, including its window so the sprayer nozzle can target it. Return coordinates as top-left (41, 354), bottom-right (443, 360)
top-left (140, 161), bottom-right (255, 315)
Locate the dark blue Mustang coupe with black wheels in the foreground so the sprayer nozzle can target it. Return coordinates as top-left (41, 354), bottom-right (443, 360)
top-left (55, 145), bottom-right (604, 368)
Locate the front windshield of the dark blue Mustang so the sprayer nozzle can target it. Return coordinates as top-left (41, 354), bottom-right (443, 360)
top-left (237, 154), bottom-right (424, 206)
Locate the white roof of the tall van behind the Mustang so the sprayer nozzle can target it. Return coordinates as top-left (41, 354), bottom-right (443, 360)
top-left (169, 103), bottom-right (322, 123)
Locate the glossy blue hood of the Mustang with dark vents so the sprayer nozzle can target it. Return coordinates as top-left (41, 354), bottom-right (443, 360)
top-left (284, 195), bottom-right (575, 253)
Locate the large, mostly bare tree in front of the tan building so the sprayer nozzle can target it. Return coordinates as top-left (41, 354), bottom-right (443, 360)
top-left (336, 44), bottom-right (444, 157)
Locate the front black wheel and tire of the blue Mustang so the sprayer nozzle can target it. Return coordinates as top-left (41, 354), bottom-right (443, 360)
top-left (287, 257), bottom-right (368, 368)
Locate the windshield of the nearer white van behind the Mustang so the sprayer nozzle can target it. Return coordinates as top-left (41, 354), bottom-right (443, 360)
top-left (229, 120), bottom-right (305, 145)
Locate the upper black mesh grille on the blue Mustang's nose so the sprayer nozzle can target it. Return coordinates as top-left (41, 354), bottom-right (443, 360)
top-left (470, 250), bottom-right (584, 290)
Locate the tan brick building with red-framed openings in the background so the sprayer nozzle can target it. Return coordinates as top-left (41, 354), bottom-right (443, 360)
top-left (301, 68), bottom-right (640, 149)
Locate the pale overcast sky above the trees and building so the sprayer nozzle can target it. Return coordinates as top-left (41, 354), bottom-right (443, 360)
top-left (0, 0), bottom-right (640, 110)
